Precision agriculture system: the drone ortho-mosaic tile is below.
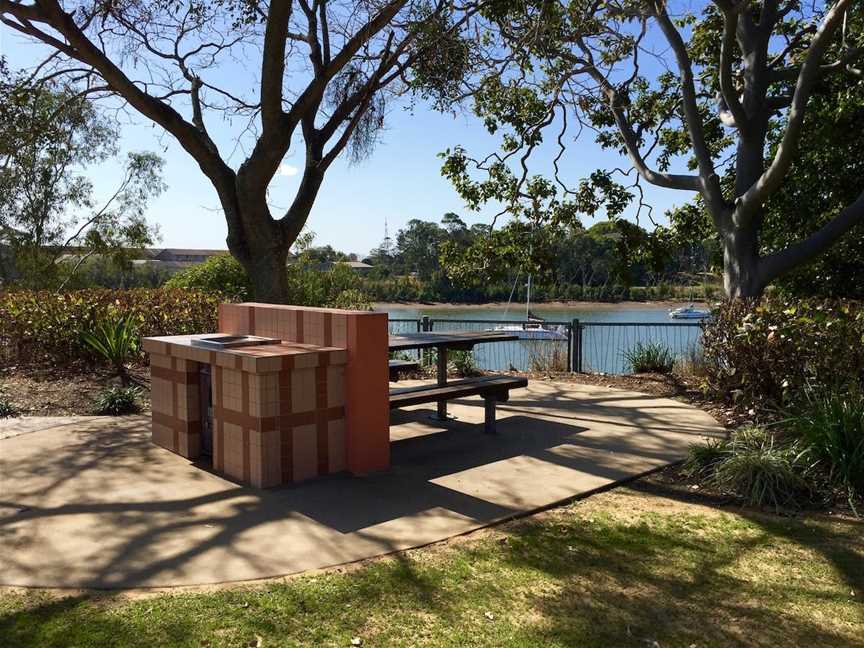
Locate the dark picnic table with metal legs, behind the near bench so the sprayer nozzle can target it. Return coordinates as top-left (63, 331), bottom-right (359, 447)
top-left (389, 331), bottom-right (527, 426)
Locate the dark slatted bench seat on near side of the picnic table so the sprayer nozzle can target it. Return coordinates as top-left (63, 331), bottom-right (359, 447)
top-left (390, 375), bottom-right (528, 433)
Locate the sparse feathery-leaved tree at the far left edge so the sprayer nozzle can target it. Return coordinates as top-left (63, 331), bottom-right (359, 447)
top-left (0, 65), bottom-right (163, 288)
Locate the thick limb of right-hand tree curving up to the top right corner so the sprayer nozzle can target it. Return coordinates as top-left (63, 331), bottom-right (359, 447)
top-left (736, 0), bottom-right (852, 215)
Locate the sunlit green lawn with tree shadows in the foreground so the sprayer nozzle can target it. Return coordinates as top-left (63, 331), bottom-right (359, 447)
top-left (0, 489), bottom-right (864, 648)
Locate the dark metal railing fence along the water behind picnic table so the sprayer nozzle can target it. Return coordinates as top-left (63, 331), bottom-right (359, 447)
top-left (390, 317), bottom-right (702, 373)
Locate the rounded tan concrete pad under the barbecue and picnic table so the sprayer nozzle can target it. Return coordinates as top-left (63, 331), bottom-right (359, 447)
top-left (0, 381), bottom-right (722, 588)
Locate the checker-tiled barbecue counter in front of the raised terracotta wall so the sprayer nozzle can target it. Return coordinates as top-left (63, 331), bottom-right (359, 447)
top-left (144, 336), bottom-right (347, 488)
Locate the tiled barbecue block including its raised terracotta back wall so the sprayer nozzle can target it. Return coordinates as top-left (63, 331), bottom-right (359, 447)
top-left (143, 303), bottom-right (390, 488)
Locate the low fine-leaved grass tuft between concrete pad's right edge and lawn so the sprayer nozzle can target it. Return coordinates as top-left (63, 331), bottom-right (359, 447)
top-left (709, 426), bottom-right (811, 509)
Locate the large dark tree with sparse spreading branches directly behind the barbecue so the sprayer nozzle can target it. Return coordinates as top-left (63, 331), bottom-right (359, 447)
top-left (0, 0), bottom-right (473, 302)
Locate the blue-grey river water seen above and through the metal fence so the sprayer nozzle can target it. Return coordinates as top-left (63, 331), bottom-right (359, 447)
top-left (379, 304), bottom-right (701, 373)
